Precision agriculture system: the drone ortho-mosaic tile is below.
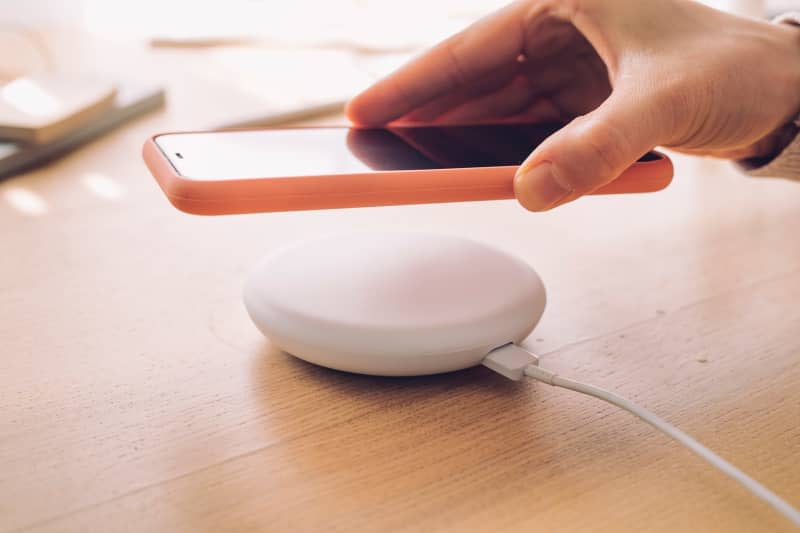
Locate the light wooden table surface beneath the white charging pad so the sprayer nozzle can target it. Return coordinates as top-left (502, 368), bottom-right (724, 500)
top-left (0, 30), bottom-right (800, 532)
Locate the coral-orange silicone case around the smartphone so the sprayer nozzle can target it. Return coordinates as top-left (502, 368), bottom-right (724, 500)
top-left (142, 127), bottom-right (673, 215)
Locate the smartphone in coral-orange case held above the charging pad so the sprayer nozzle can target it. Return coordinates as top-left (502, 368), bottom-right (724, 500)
top-left (143, 124), bottom-right (672, 215)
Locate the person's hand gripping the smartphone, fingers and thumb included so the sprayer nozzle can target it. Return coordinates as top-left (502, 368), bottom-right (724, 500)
top-left (347, 0), bottom-right (800, 211)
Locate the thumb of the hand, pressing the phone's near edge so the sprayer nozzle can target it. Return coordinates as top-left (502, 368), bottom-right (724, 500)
top-left (514, 91), bottom-right (660, 211)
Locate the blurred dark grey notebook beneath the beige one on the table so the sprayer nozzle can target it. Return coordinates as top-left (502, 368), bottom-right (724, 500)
top-left (0, 83), bottom-right (165, 178)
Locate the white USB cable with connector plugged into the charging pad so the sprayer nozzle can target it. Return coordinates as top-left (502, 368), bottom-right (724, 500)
top-left (483, 344), bottom-right (800, 527)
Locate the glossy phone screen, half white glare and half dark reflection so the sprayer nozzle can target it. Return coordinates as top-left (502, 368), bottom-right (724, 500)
top-left (156, 124), bottom-right (576, 180)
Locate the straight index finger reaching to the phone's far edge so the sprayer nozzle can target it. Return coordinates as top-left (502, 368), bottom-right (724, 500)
top-left (346, 3), bottom-right (523, 125)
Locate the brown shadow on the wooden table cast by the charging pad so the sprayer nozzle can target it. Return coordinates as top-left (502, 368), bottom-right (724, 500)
top-left (245, 340), bottom-right (641, 483)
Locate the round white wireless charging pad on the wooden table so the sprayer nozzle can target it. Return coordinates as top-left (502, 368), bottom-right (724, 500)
top-left (244, 233), bottom-right (545, 376)
